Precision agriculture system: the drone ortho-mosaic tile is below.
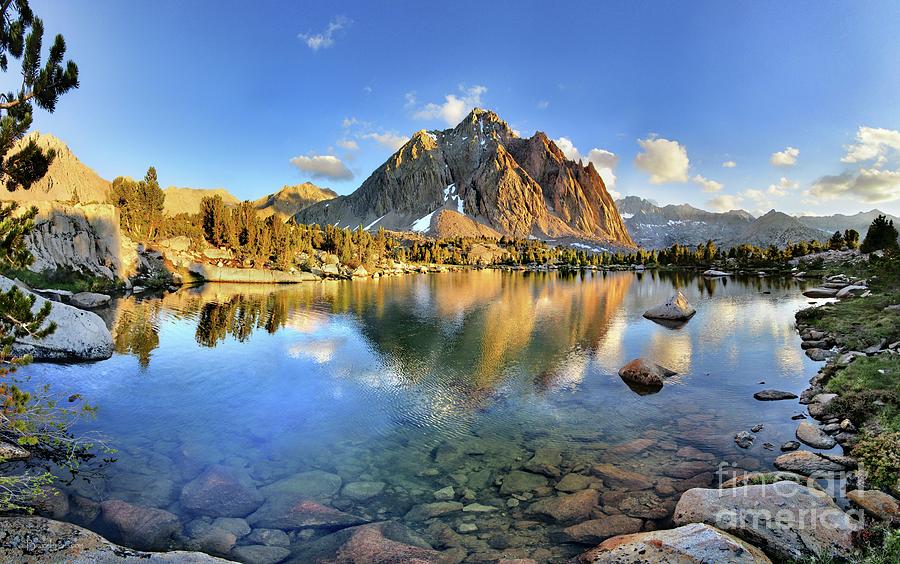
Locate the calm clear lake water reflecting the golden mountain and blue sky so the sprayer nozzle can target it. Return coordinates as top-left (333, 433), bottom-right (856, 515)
top-left (19, 271), bottom-right (815, 561)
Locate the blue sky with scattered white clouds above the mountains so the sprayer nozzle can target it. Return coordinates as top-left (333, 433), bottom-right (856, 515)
top-left (17, 0), bottom-right (900, 214)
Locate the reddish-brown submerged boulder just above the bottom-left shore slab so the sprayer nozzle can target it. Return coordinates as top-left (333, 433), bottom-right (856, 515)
top-left (100, 499), bottom-right (181, 550)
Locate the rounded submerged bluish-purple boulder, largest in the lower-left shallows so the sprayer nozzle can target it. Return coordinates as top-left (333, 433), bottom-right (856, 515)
top-left (181, 466), bottom-right (263, 517)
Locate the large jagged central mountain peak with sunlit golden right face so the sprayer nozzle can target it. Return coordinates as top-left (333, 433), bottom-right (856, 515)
top-left (296, 109), bottom-right (633, 247)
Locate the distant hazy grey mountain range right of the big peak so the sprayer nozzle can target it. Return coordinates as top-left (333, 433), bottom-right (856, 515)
top-left (616, 196), bottom-right (900, 249)
